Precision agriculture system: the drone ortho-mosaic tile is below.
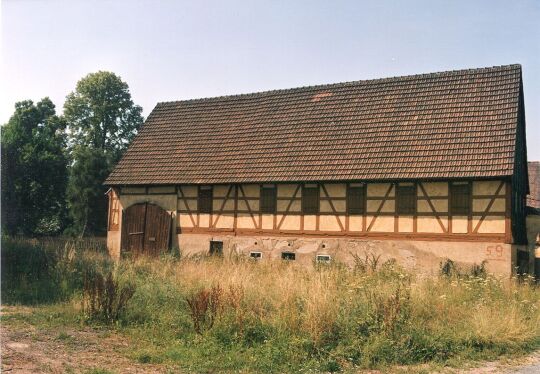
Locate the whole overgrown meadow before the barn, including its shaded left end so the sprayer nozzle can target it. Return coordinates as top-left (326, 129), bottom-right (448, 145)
top-left (2, 238), bottom-right (540, 373)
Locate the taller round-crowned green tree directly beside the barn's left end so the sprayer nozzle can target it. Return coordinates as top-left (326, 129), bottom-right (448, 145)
top-left (64, 71), bottom-right (143, 235)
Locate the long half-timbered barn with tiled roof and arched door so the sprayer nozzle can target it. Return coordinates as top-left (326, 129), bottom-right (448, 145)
top-left (106, 65), bottom-right (533, 275)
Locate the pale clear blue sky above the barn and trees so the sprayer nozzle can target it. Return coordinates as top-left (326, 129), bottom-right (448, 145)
top-left (0, 0), bottom-right (540, 160)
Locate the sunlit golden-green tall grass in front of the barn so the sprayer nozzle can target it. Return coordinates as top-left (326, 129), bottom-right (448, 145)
top-left (1, 238), bottom-right (540, 372)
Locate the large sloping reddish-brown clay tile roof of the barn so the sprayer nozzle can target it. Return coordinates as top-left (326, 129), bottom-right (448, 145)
top-left (106, 65), bottom-right (521, 185)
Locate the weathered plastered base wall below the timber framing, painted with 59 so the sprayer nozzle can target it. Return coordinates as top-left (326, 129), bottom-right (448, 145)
top-left (178, 234), bottom-right (518, 277)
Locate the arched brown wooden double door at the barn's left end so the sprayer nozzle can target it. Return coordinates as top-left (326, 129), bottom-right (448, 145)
top-left (122, 203), bottom-right (171, 256)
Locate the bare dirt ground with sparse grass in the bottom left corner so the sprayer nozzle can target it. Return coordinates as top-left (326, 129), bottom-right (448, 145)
top-left (1, 308), bottom-right (173, 374)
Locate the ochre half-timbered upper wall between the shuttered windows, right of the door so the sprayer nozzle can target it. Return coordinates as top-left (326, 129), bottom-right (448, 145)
top-left (178, 181), bottom-right (507, 236)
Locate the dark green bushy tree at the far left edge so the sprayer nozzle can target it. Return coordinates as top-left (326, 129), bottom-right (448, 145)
top-left (1, 98), bottom-right (68, 235)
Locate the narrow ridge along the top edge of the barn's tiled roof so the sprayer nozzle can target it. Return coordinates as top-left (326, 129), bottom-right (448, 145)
top-left (155, 64), bottom-right (521, 108)
